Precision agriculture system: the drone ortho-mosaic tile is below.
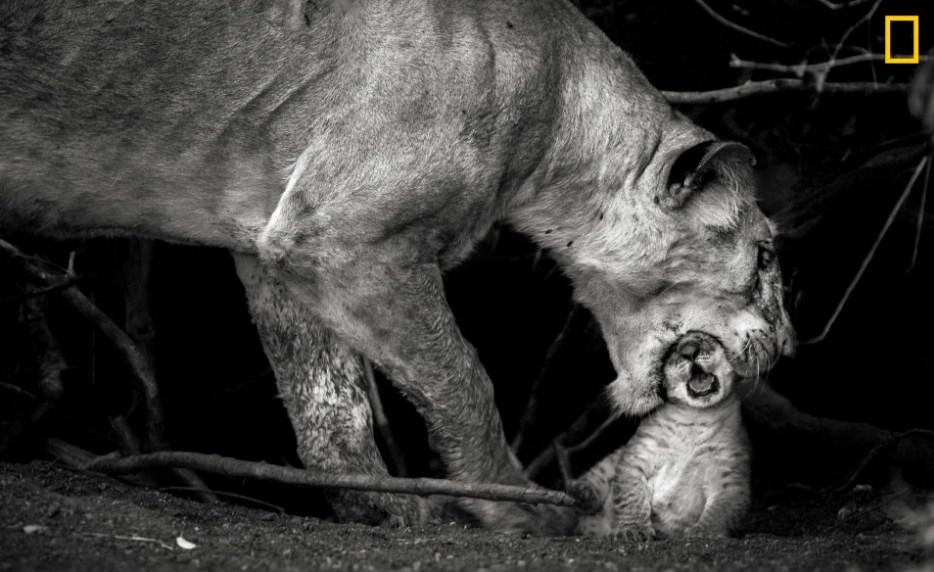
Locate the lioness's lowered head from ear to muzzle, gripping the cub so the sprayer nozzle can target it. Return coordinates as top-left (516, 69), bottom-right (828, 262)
top-left (592, 132), bottom-right (794, 414)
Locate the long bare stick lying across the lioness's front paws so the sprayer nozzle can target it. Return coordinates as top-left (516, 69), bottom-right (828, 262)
top-left (85, 451), bottom-right (577, 506)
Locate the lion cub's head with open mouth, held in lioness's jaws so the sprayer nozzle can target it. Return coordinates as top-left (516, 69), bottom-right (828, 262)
top-left (663, 332), bottom-right (736, 409)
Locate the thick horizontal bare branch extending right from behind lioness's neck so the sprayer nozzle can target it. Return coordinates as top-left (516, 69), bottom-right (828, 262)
top-left (662, 78), bottom-right (910, 105)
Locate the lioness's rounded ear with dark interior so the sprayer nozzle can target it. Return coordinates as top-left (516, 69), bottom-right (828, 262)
top-left (655, 141), bottom-right (756, 210)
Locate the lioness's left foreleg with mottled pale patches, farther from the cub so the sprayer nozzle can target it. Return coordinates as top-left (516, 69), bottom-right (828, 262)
top-left (234, 255), bottom-right (425, 524)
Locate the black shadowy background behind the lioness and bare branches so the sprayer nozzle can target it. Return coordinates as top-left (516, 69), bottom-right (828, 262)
top-left (0, 0), bottom-right (934, 516)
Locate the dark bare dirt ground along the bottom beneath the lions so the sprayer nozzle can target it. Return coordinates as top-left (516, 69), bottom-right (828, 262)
top-left (0, 462), bottom-right (923, 571)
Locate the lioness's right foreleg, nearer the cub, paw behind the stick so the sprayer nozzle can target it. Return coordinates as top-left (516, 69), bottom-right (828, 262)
top-left (270, 249), bottom-right (571, 532)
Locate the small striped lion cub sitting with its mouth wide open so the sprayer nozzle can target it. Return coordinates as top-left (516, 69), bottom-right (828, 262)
top-left (572, 334), bottom-right (749, 540)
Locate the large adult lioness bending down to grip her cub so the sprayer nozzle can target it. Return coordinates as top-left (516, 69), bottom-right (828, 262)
top-left (0, 0), bottom-right (792, 530)
